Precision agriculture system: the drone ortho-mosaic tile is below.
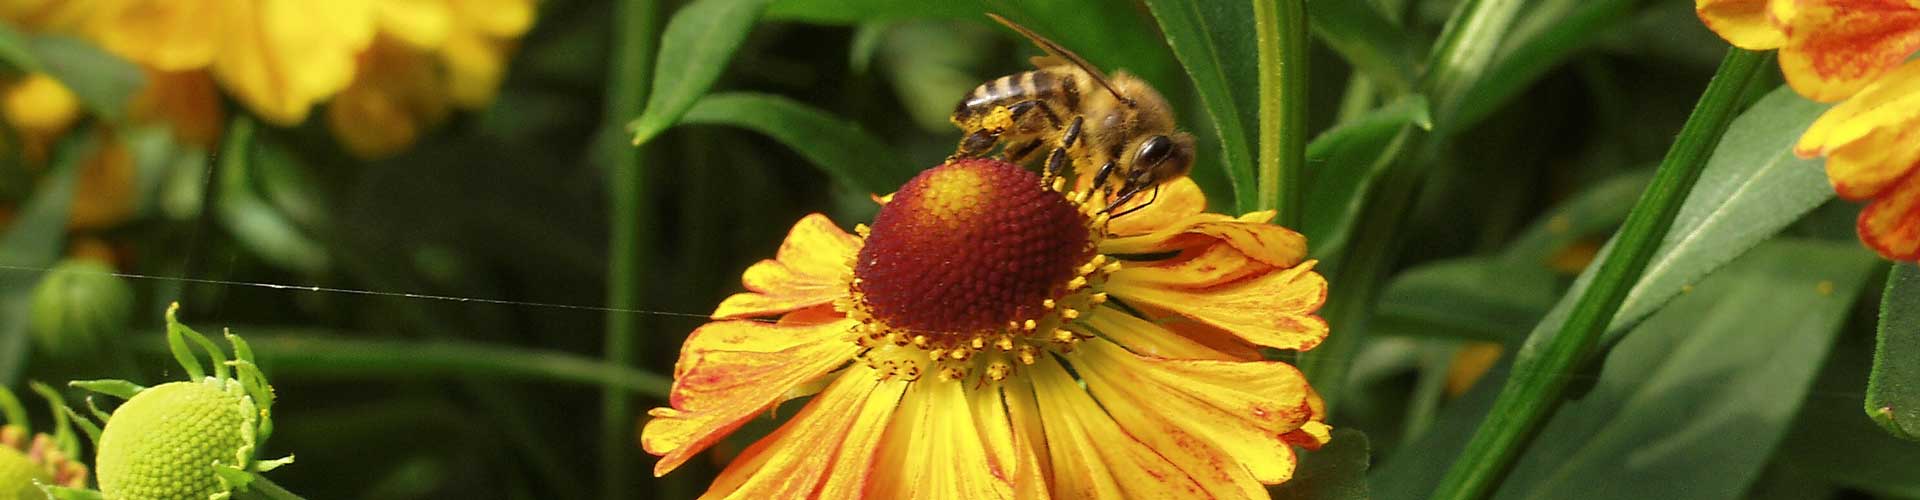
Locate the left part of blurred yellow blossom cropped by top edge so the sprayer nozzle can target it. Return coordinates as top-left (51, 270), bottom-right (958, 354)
top-left (90, 0), bottom-right (374, 125)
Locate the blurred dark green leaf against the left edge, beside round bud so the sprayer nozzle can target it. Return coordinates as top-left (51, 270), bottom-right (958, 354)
top-left (0, 133), bottom-right (87, 385)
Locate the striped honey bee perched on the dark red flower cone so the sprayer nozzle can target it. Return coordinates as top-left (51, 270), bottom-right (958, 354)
top-left (950, 13), bottom-right (1194, 217)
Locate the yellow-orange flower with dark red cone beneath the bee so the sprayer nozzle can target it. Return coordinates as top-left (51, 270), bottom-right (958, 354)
top-left (641, 160), bottom-right (1329, 498)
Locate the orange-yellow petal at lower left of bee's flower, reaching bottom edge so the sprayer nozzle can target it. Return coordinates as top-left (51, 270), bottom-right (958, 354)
top-left (701, 371), bottom-right (906, 498)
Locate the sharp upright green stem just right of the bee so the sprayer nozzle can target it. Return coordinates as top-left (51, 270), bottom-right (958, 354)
top-left (1254, 0), bottom-right (1308, 227)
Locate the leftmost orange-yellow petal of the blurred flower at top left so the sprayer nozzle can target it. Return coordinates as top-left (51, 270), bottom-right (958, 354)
top-left (88, 0), bottom-right (219, 71)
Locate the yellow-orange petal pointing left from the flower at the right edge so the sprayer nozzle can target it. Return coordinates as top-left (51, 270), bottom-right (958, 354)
top-left (1793, 62), bottom-right (1920, 158)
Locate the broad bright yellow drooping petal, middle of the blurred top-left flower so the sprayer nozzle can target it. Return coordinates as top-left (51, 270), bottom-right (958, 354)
top-left (213, 0), bottom-right (374, 125)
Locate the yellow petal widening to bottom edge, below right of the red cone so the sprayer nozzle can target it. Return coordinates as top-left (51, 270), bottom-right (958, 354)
top-left (1008, 356), bottom-right (1204, 498)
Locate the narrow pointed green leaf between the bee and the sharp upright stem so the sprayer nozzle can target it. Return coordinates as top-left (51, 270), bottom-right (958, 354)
top-left (1146, 0), bottom-right (1260, 212)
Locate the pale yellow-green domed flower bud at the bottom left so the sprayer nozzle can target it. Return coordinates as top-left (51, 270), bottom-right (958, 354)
top-left (94, 379), bottom-right (257, 498)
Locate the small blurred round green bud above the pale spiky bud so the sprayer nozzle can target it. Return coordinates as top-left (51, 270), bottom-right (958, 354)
top-left (31, 260), bottom-right (132, 358)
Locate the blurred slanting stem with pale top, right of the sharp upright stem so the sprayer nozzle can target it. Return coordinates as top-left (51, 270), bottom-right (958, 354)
top-left (1300, 0), bottom-right (1526, 412)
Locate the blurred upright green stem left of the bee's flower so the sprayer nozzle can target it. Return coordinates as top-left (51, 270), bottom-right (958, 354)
top-left (599, 0), bottom-right (659, 498)
